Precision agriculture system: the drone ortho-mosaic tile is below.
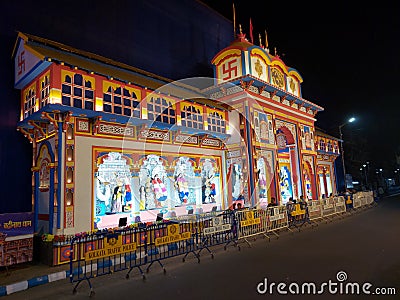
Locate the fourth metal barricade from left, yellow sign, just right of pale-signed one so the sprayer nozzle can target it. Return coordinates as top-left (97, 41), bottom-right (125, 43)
top-left (235, 209), bottom-right (267, 247)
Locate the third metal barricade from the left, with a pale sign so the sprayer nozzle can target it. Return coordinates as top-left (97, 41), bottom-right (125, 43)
top-left (196, 210), bottom-right (237, 258)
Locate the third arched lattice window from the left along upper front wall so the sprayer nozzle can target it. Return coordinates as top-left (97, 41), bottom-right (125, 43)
top-left (147, 98), bottom-right (176, 124)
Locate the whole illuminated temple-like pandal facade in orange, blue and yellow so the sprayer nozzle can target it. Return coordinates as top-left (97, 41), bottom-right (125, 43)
top-left (13, 33), bottom-right (338, 234)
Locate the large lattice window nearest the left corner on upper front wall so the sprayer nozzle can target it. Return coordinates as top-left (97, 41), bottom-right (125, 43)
top-left (62, 74), bottom-right (94, 110)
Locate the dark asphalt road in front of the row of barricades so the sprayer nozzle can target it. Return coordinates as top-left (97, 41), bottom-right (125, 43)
top-left (7, 196), bottom-right (400, 300)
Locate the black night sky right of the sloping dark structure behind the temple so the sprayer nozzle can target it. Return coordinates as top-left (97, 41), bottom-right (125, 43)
top-left (203, 0), bottom-right (400, 170)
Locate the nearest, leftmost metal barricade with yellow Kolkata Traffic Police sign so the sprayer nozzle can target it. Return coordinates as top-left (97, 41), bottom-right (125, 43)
top-left (69, 228), bottom-right (147, 296)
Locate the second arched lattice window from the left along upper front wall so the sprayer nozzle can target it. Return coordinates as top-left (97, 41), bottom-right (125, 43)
top-left (103, 86), bottom-right (140, 118)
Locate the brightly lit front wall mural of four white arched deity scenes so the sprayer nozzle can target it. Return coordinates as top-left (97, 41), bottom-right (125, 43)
top-left (94, 151), bottom-right (222, 228)
